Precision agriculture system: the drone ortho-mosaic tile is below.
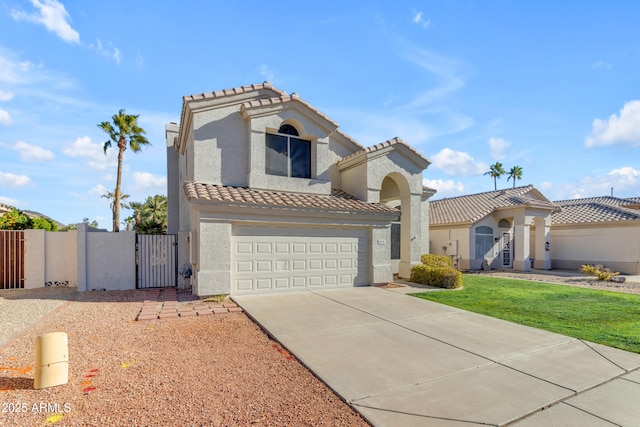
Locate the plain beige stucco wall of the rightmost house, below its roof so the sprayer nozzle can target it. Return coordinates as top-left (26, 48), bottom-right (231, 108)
top-left (550, 224), bottom-right (640, 274)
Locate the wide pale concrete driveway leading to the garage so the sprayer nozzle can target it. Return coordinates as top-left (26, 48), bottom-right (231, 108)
top-left (234, 287), bottom-right (640, 427)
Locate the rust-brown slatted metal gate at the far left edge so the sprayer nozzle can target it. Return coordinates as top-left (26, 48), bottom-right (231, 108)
top-left (0, 230), bottom-right (24, 289)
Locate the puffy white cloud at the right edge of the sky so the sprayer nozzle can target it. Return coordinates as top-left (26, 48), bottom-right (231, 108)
top-left (584, 100), bottom-right (640, 148)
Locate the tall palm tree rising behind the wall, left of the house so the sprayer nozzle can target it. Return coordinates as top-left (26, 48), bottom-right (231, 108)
top-left (98, 109), bottom-right (151, 232)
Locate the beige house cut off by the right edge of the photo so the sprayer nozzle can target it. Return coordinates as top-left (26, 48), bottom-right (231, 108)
top-left (550, 197), bottom-right (640, 274)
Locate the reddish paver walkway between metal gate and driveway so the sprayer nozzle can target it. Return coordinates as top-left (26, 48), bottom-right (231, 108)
top-left (136, 288), bottom-right (242, 320)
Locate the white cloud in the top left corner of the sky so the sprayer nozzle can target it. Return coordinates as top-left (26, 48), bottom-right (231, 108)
top-left (11, 0), bottom-right (80, 43)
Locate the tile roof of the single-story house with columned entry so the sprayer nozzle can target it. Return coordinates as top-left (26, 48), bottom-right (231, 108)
top-left (429, 185), bottom-right (557, 225)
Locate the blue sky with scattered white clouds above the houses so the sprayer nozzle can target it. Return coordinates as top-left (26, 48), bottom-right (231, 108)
top-left (0, 0), bottom-right (640, 229)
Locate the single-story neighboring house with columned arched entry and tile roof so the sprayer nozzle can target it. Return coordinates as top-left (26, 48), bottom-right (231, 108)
top-left (429, 186), bottom-right (557, 271)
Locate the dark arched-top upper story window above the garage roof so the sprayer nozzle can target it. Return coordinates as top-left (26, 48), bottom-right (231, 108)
top-left (265, 124), bottom-right (311, 178)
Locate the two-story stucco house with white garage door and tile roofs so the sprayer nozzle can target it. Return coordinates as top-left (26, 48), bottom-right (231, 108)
top-left (166, 82), bottom-right (435, 295)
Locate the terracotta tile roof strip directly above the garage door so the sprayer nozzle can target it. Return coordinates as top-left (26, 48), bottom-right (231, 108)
top-left (184, 182), bottom-right (399, 214)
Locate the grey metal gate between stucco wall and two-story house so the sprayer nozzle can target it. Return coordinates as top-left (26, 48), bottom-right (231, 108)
top-left (136, 234), bottom-right (178, 289)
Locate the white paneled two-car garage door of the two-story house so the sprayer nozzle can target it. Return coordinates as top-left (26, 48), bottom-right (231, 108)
top-left (232, 226), bottom-right (370, 294)
